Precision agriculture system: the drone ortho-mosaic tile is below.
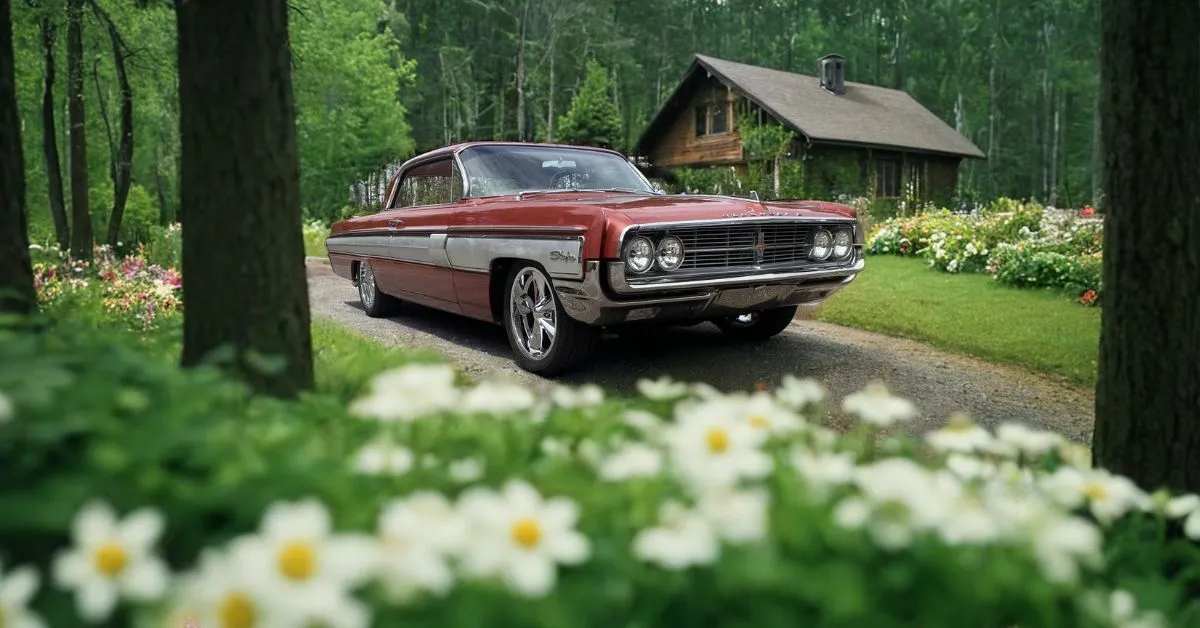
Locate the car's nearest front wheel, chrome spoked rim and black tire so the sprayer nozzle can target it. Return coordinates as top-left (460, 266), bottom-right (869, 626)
top-left (502, 263), bottom-right (600, 377)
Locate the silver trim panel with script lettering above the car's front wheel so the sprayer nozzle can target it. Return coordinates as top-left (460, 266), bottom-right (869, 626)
top-left (445, 235), bottom-right (583, 279)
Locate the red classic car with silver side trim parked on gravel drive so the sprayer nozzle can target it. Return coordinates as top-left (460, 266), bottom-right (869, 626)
top-left (325, 142), bottom-right (863, 376)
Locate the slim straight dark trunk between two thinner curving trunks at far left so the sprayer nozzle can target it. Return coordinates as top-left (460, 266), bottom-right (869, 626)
top-left (67, 0), bottom-right (92, 259)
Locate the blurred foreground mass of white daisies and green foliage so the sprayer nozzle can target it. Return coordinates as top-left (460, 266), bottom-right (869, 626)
top-left (0, 321), bottom-right (1200, 628)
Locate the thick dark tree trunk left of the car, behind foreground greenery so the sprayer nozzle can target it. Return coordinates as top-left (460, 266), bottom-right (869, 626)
top-left (175, 0), bottom-right (313, 396)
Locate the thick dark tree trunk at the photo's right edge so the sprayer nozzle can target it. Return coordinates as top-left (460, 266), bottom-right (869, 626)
top-left (1092, 0), bottom-right (1200, 492)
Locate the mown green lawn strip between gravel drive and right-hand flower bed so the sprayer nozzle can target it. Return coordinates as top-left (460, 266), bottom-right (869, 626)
top-left (818, 256), bottom-right (1100, 385)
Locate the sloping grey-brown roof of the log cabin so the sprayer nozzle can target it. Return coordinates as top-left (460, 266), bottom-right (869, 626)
top-left (635, 54), bottom-right (984, 159)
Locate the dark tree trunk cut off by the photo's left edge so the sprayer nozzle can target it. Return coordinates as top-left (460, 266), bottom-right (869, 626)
top-left (0, 0), bottom-right (37, 313)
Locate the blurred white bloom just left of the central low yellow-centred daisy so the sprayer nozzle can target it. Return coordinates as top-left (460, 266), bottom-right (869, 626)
top-left (379, 491), bottom-right (467, 602)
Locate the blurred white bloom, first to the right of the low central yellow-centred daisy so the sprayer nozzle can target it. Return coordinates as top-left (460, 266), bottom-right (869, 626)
top-left (634, 502), bottom-right (721, 570)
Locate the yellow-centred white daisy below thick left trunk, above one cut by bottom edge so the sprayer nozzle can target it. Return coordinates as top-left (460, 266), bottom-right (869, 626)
top-left (236, 498), bottom-right (376, 599)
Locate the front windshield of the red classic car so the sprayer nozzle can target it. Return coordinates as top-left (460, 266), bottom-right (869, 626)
top-left (458, 145), bottom-right (656, 197)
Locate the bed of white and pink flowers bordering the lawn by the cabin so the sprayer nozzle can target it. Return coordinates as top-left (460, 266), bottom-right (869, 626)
top-left (866, 199), bottom-right (1103, 305)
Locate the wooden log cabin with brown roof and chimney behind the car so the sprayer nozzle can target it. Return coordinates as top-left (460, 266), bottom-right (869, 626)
top-left (634, 54), bottom-right (984, 204)
